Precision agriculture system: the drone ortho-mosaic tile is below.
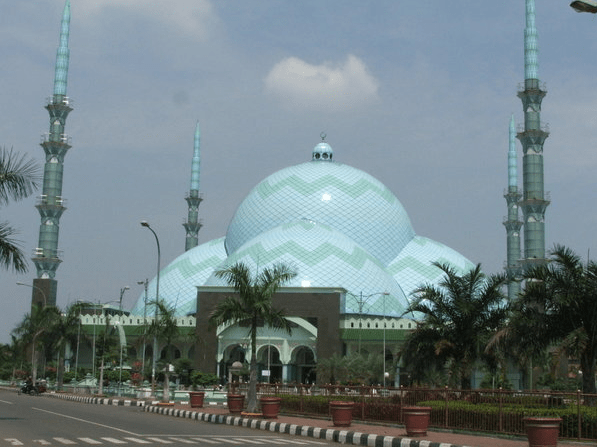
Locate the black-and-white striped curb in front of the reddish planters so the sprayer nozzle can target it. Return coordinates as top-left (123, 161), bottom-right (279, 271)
top-left (143, 405), bottom-right (465, 447)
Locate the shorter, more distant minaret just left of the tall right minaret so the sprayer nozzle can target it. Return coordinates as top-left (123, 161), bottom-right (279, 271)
top-left (504, 115), bottom-right (522, 300)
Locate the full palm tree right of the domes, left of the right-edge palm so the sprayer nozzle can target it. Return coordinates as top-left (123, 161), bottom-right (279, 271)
top-left (401, 263), bottom-right (507, 389)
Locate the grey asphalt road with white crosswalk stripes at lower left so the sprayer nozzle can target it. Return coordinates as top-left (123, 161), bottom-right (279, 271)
top-left (0, 390), bottom-right (335, 447)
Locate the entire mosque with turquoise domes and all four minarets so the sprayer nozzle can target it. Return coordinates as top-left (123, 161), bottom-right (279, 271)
top-left (32, 0), bottom-right (549, 384)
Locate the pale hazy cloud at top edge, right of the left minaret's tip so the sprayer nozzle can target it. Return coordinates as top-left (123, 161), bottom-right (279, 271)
top-left (72, 0), bottom-right (215, 39)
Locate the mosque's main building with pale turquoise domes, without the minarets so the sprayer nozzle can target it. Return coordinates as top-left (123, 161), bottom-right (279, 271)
top-left (131, 137), bottom-right (473, 382)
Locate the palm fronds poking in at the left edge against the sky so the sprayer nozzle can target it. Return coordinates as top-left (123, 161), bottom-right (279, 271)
top-left (0, 148), bottom-right (39, 273)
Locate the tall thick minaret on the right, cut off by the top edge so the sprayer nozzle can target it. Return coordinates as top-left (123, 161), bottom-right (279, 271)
top-left (517, 0), bottom-right (549, 269)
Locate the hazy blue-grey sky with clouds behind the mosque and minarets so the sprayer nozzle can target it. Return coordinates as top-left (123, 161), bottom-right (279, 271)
top-left (0, 0), bottom-right (597, 343)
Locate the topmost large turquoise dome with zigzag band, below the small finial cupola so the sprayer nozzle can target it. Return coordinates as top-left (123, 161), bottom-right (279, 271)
top-left (225, 161), bottom-right (415, 265)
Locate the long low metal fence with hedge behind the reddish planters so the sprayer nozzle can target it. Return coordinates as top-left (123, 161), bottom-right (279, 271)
top-left (243, 384), bottom-right (597, 440)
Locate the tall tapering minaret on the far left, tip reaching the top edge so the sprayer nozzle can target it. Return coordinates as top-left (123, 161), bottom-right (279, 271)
top-left (31, 0), bottom-right (72, 306)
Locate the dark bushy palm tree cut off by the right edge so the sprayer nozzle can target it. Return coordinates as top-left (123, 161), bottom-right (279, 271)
top-left (501, 245), bottom-right (597, 394)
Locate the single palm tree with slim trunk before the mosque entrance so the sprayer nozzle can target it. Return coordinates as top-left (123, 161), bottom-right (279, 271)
top-left (209, 262), bottom-right (297, 412)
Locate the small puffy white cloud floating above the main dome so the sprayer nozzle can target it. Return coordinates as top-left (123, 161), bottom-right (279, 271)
top-left (265, 55), bottom-right (378, 111)
